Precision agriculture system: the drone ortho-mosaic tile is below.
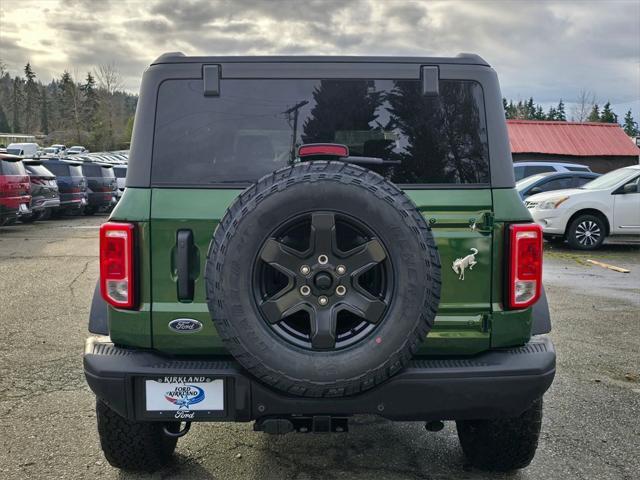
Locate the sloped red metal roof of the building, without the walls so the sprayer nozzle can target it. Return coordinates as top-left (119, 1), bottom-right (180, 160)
top-left (507, 120), bottom-right (640, 157)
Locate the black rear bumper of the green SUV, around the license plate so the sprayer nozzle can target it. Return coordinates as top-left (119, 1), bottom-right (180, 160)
top-left (84, 336), bottom-right (556, 421)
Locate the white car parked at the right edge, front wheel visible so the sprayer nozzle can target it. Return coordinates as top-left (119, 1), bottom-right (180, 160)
top-left (525, 165), bottom-right (640, 250)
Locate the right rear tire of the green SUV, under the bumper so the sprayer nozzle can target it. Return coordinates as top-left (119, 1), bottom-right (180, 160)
top-left (456, 399), bottom-right (542, 472)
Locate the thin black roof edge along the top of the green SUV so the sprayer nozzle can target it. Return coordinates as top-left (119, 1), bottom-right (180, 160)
top-left (151, 52), bottom-right (489, 66)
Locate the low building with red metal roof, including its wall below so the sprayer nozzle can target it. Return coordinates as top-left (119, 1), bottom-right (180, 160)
top-left (507, 120), bottom-right (640, 173)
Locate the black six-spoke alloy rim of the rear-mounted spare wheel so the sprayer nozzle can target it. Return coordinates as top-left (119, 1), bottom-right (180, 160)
top-left (253, 211), bottom-right (393, 350)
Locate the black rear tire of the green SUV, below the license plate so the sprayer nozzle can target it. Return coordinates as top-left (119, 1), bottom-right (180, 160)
top-left (96, 399), bottom-right (179, 472)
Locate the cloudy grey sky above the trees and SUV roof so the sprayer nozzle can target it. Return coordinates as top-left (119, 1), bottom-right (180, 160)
top-left (0, 0), bottom-right (640, 119)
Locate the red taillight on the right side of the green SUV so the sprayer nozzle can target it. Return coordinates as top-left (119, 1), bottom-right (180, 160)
top-left (508, 223), bottom-right (542, 308)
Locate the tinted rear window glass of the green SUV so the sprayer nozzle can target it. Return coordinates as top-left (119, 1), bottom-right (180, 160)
top-left (152, 79), bottom-right (489, 185)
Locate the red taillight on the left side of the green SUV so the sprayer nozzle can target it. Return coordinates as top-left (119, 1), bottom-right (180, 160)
top-left (100, 222), bottom-right (135, 308)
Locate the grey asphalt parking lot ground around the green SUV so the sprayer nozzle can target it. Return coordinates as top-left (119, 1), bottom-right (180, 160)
top-left (0, 216), bottom-right (640, 479)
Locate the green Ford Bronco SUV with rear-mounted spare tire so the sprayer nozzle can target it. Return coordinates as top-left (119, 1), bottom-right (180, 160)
top-left (84, 53), bottom-right (555, 471)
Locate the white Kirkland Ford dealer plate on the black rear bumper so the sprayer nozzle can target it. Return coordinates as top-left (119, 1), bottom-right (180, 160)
top-left (145, 376), bottom-right (224, 418)
